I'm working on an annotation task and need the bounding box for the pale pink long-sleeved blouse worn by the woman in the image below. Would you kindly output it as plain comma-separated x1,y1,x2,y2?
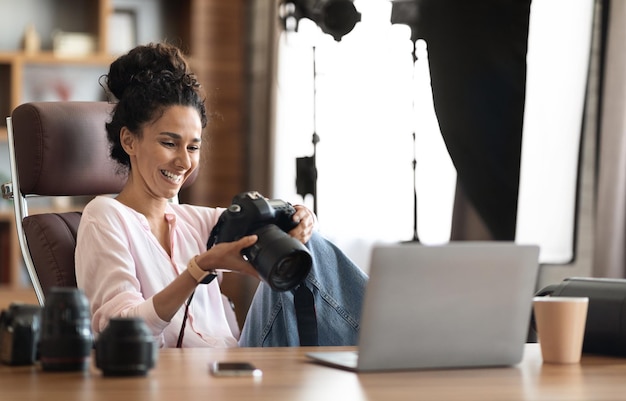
76,196,237,347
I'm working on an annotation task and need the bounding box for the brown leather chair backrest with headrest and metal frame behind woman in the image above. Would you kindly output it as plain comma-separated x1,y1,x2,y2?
7,102,125,305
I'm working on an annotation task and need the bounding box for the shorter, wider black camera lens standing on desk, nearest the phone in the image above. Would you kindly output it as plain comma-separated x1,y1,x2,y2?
96,318,157,376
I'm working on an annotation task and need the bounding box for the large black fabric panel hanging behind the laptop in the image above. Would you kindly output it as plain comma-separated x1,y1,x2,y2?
394,0,531,240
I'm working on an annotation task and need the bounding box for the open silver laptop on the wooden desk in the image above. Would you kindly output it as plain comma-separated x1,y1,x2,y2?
307,242,539,372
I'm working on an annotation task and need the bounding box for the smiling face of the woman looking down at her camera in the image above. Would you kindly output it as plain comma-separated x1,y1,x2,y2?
120,106,202,199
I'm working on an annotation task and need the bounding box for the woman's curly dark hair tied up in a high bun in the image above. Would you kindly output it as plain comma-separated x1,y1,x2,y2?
103,43,208,171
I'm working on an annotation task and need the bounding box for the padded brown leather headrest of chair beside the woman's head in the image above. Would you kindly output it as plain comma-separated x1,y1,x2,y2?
11,102,197,196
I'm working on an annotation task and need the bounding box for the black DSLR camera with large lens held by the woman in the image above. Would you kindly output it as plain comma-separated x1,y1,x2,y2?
207,191,313,291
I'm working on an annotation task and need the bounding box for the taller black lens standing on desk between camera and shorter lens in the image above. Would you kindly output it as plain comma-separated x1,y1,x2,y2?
40,287,93,371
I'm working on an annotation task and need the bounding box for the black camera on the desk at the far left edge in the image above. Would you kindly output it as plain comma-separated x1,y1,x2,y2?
0,303,42,365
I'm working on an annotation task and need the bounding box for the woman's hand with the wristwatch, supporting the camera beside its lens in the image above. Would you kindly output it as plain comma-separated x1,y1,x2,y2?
196,235,260,279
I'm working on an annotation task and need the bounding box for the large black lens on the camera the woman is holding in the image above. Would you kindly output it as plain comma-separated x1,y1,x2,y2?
244,224,313,291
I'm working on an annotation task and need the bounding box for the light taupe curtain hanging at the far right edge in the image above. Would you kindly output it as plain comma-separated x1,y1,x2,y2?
593,0,626,278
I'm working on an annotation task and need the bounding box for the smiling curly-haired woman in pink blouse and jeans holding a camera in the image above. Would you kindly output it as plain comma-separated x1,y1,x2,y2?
76,44,366,347
